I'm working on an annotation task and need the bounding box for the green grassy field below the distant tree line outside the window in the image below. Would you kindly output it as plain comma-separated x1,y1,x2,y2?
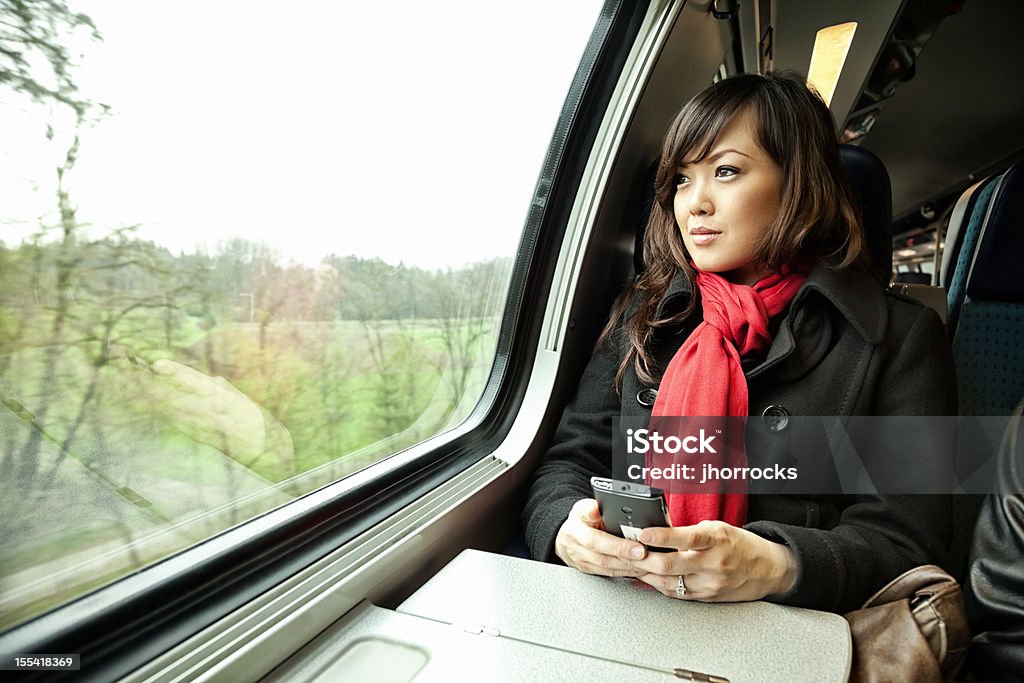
0,310,497,624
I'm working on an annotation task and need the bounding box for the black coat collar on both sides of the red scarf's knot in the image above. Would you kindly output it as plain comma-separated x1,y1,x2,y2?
657,263,887,344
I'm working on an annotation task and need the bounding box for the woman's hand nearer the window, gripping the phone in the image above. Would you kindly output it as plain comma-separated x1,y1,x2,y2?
555,498,647,577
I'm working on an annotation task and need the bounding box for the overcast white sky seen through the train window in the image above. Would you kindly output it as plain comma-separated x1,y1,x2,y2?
0,0,601,267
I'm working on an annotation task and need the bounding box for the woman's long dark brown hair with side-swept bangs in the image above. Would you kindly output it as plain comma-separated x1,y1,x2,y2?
598,73,866,389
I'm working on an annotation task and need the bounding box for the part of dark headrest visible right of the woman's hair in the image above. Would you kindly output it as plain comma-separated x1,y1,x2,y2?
839,144,893,275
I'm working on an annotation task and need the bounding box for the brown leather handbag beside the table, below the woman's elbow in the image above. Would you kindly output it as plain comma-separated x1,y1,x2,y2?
845,564,971,682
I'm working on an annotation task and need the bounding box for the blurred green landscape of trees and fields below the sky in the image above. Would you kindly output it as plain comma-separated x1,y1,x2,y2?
0,229,510,626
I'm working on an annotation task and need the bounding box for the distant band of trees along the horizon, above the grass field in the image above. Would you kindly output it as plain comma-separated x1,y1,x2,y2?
0,236,511,327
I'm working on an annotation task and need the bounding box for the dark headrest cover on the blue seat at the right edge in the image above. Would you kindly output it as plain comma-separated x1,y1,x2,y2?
967,162,1024,303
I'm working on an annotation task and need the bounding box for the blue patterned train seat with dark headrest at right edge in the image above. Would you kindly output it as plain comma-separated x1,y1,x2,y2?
950,162,1024,415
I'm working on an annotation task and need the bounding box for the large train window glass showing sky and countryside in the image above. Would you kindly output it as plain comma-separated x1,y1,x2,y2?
0,0,601,628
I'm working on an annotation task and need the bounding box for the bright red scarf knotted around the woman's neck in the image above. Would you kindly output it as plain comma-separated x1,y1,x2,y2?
651,270,806,526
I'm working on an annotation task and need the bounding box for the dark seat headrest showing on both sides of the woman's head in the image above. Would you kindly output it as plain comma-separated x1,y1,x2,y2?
633,144,893,275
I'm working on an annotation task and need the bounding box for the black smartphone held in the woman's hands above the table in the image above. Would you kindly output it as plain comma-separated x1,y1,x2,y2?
590,477,676,553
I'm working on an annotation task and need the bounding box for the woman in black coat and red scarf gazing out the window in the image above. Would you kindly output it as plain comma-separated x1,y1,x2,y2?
524,75,956,611
